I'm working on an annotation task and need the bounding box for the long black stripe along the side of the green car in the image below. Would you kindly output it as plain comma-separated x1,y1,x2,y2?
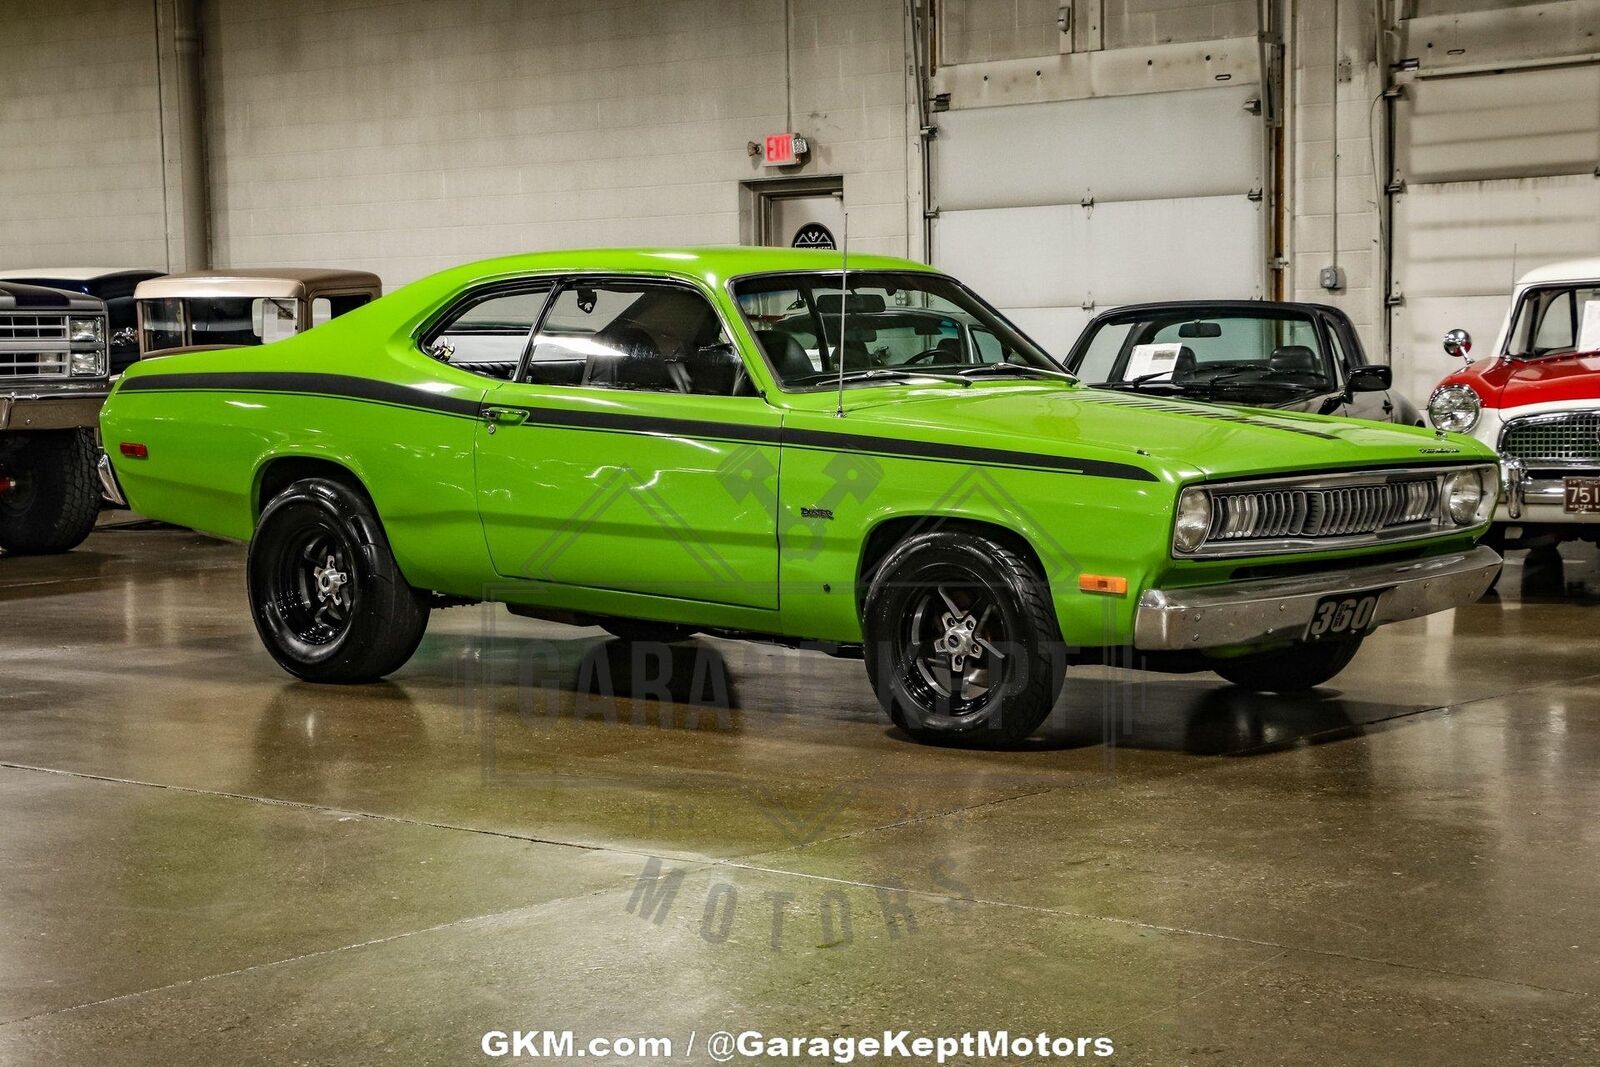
120,371,1158,482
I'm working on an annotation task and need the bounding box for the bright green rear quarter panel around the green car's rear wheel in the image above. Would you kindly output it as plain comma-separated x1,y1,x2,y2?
101,331,488,592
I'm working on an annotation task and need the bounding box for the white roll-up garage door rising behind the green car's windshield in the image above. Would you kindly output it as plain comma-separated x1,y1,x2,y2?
933,85,1266,354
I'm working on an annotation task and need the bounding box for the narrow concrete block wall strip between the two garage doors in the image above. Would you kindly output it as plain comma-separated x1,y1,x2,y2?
1286,0,1386,358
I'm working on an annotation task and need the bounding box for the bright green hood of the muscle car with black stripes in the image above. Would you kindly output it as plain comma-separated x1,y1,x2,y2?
812,384,1494,478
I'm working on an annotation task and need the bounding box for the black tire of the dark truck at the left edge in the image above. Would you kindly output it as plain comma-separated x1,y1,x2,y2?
0,429,101,555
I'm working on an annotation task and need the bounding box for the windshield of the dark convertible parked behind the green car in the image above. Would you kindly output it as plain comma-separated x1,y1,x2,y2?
1067,307,1338,395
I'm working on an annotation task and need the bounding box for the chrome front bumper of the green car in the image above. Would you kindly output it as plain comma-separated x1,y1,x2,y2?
1133,545,1501,651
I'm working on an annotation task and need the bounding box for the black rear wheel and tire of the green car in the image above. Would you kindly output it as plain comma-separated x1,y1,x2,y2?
246,478,429,681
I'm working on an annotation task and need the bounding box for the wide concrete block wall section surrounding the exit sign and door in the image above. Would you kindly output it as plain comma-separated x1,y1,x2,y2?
206,0,912,286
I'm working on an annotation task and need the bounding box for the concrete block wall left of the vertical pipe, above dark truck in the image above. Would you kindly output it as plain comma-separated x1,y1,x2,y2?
0,0,166,267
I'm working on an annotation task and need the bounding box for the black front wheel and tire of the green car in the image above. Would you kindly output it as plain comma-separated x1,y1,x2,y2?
862,531,1066,745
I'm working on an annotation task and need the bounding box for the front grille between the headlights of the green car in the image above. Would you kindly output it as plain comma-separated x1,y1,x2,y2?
1206,475,1438,544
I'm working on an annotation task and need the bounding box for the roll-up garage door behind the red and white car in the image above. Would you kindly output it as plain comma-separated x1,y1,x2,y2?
1389,64,1600,402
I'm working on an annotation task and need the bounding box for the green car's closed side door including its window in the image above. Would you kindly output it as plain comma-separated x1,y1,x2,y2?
477,277,781,609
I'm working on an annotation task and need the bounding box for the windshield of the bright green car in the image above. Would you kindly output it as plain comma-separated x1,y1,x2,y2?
733,270,1066,389
